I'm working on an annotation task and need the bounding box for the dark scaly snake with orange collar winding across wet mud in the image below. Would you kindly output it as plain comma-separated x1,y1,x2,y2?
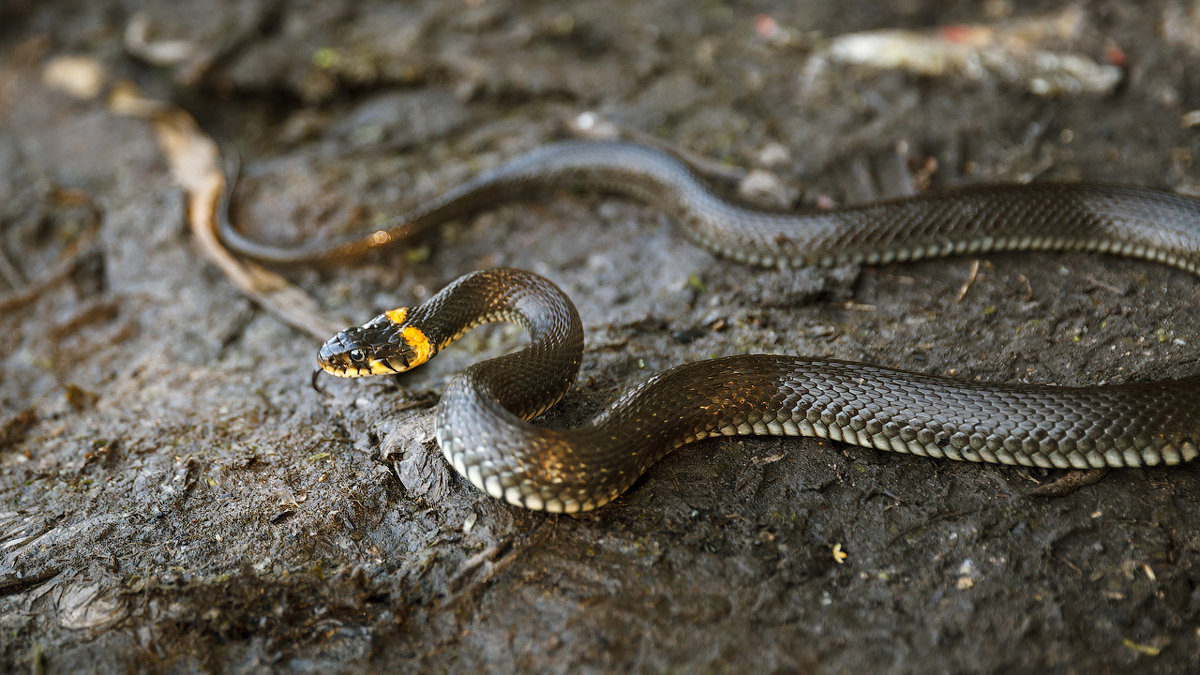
222,141,1200,513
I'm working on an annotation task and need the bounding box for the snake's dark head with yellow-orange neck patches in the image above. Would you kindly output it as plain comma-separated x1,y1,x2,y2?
317,309,436,377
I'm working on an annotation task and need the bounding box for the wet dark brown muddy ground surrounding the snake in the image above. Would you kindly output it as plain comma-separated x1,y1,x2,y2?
0,0,1200,673
